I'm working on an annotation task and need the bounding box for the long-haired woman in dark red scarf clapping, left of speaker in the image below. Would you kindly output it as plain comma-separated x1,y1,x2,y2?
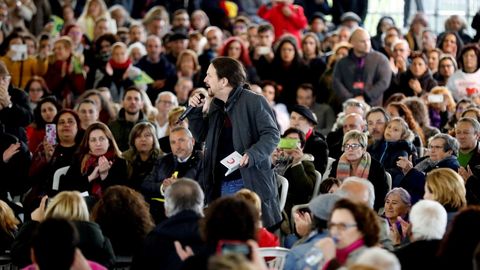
59,122,127,199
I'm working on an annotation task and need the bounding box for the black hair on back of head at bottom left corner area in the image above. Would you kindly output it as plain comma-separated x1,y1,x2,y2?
32,218,79,270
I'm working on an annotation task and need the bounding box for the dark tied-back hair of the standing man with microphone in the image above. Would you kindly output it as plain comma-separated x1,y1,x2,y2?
212,57,247,88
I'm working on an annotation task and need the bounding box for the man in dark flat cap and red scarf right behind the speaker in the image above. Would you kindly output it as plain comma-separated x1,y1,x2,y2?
290,105,328,174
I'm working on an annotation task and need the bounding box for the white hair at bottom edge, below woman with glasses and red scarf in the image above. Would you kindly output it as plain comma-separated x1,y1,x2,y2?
355,247,402,270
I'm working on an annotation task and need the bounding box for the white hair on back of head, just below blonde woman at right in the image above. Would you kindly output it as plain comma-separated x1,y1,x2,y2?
409,200,447,241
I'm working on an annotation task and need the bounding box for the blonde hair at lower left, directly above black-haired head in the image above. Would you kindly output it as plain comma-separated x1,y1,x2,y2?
45,191,90,221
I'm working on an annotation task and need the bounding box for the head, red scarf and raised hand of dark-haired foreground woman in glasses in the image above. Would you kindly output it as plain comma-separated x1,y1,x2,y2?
315,199,380,269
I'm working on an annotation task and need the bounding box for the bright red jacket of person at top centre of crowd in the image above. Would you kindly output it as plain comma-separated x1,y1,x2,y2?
258,3,308,46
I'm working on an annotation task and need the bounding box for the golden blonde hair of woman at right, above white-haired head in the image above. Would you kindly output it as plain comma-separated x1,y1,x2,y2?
425,168,467,209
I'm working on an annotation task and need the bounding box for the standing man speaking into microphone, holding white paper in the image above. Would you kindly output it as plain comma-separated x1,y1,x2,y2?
187,57,281,227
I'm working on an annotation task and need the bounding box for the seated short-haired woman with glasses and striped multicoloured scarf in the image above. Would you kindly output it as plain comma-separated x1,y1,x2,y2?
330,130,388,210
